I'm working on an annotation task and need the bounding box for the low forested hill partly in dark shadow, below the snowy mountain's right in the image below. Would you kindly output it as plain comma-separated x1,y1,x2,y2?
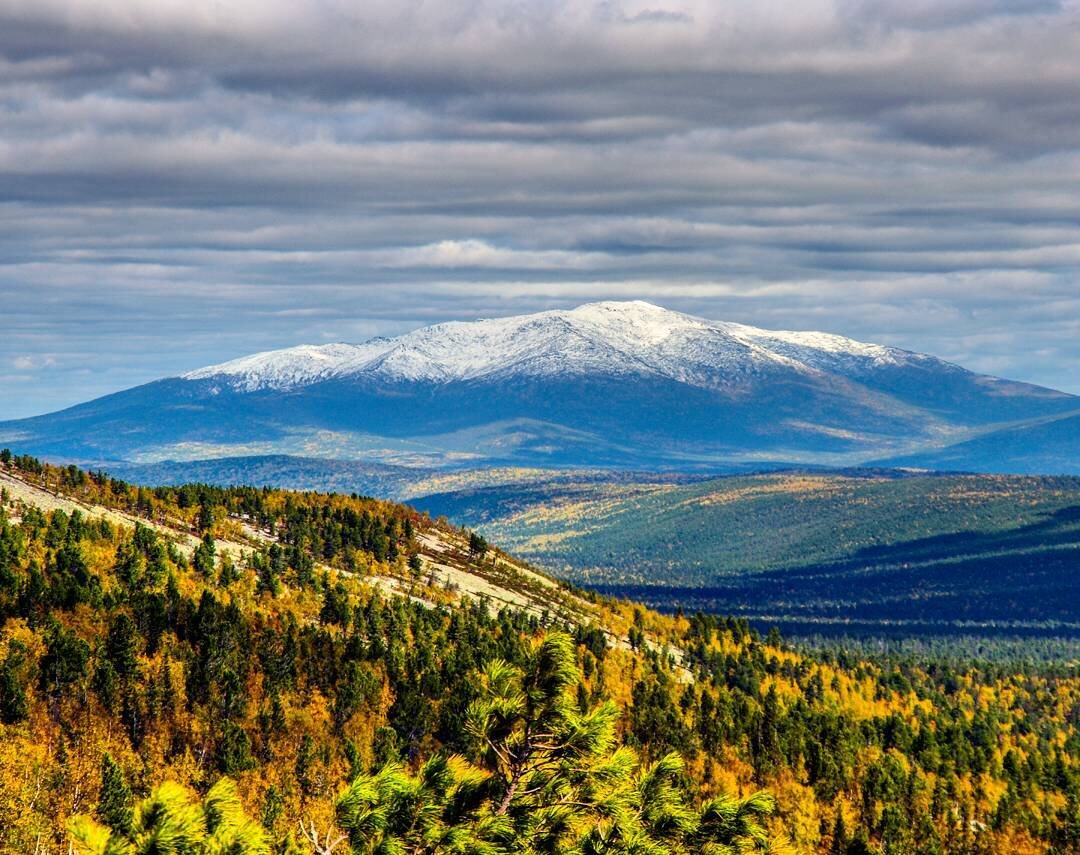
416,470,1080,638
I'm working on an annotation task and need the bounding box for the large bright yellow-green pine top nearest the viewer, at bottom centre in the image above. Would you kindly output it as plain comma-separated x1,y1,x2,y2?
337,634,773,853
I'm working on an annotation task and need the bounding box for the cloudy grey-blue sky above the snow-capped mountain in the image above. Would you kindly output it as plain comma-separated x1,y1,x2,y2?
0,0,1080,419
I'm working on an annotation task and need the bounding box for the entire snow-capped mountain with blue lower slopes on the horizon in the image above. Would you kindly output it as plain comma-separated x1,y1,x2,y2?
0,301,1080,470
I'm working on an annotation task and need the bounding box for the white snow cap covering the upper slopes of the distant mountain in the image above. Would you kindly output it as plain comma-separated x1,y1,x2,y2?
184,300,914,391
